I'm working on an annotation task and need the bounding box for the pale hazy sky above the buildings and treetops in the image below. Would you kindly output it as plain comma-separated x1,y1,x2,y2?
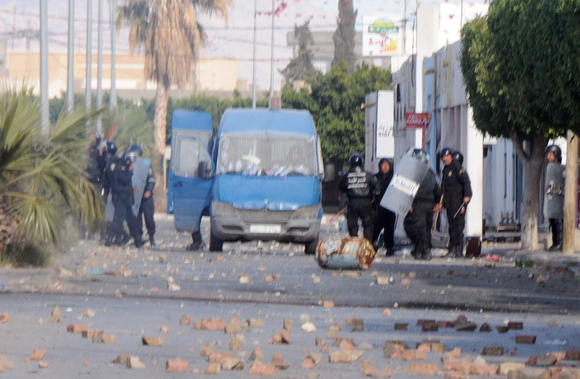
0,0,483,90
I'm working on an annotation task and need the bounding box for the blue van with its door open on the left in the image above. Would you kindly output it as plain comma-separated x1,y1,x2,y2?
168,109,332,254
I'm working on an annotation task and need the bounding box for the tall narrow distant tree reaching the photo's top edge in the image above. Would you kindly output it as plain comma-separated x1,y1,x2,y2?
331,0,358,73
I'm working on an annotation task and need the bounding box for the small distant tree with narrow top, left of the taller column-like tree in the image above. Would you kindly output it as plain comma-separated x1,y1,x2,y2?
280,21,317,82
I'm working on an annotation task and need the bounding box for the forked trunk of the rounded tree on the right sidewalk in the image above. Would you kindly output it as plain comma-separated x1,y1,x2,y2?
511,132,548,250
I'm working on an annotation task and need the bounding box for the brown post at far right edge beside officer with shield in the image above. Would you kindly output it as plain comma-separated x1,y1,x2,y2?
562,130,578,254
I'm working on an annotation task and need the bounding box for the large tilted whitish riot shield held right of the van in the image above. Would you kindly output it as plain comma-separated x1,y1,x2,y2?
380,154,429,217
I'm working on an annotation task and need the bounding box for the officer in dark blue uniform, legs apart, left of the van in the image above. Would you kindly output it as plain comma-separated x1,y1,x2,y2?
105,156,144,247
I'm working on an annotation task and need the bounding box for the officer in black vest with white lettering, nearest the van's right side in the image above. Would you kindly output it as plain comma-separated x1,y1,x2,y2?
339,153,381,242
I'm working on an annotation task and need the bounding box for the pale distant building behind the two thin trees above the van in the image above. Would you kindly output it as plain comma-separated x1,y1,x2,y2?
286,31,391,74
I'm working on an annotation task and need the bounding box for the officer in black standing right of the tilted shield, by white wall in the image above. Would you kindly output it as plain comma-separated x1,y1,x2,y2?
441,160,472,257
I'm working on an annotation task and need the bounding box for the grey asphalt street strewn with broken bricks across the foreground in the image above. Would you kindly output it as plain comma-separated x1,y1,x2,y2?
0,215,580,378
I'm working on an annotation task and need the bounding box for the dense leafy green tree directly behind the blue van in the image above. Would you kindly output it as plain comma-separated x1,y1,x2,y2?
282,62,391,167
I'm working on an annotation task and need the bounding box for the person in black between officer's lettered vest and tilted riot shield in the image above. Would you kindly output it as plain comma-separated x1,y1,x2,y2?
373,158,397,256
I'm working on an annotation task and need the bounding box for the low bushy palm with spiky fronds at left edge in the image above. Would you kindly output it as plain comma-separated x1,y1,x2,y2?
0,85,102,257
